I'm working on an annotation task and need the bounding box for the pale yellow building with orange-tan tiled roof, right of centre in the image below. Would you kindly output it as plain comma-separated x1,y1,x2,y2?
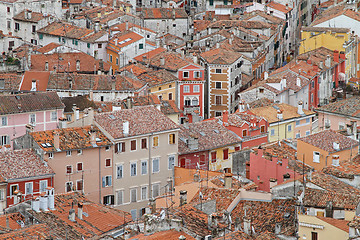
250,103,315,142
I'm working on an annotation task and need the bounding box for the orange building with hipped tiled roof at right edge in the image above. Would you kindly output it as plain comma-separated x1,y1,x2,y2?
297,130,359,171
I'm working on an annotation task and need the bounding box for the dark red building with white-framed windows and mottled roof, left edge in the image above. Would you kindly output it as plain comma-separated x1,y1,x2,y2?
0,149,55,207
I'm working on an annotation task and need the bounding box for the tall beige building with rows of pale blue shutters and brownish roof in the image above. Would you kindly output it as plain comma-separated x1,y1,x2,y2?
95,106,179,219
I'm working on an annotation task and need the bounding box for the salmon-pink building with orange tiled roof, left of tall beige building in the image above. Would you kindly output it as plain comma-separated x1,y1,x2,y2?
15,126,114,205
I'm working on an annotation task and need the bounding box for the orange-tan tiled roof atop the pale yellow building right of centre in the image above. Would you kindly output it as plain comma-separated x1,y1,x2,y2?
250,103,315,123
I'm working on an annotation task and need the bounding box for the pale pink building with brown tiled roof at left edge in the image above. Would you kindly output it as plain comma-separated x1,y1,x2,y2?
0,92,64,148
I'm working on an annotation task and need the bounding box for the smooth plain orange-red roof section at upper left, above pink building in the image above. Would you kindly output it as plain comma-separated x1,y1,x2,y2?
19,71,50,92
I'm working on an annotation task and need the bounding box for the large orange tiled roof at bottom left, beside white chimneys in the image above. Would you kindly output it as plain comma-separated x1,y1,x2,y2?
30,193,131,240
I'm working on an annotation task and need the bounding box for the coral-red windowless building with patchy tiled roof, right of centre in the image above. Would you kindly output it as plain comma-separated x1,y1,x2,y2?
247,142,309,192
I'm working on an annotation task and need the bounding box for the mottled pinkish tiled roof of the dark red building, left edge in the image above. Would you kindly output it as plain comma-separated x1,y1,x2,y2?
0,149,54,180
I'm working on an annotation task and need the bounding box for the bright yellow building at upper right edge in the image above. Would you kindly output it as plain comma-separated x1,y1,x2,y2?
299,27,357,77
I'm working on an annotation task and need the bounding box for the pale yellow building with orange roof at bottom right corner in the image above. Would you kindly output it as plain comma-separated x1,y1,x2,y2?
298,214,349,240
